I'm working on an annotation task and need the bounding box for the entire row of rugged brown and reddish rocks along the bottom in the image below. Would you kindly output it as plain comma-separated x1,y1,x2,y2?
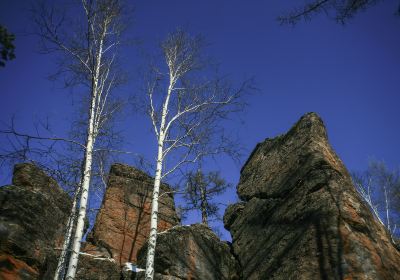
0,113,400,280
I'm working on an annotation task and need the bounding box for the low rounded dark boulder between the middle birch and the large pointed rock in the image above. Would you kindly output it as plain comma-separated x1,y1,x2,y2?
138,224,240,280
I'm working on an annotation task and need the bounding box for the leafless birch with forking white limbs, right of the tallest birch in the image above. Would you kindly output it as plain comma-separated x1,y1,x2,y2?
145,31,245,280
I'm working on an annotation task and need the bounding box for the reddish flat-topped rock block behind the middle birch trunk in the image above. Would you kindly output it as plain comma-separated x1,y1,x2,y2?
88,164,179,265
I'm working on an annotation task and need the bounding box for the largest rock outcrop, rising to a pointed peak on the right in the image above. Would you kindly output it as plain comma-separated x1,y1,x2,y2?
224,113,400,280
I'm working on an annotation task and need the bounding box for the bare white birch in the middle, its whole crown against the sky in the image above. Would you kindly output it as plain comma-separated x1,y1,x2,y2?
145,30,249,280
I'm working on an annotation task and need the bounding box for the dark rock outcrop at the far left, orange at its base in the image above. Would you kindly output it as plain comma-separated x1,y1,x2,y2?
0,163,71,279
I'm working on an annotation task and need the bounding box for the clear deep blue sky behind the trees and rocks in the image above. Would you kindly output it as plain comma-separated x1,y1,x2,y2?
0,0,400,240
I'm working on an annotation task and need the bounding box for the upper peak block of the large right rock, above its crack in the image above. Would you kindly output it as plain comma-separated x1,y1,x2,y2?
237,113,347,200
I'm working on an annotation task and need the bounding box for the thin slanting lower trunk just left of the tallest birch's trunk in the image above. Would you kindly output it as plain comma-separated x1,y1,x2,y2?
54,187,80,280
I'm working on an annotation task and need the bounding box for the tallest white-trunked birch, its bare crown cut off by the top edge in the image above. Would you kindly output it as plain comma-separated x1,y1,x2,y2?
35,0,123,279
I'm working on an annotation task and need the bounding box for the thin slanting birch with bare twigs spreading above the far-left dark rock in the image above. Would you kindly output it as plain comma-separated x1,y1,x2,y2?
0,112,121,279
